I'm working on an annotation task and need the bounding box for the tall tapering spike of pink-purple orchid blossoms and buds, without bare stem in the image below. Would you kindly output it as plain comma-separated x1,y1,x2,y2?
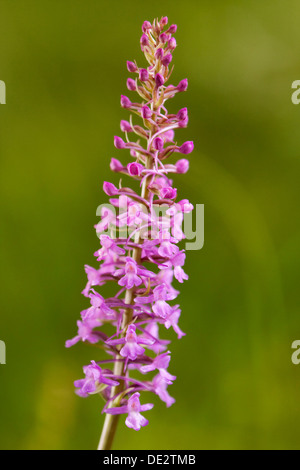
66,17,193,436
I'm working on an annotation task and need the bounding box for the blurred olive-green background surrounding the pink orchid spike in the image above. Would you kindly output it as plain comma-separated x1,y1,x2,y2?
0,0,300,450
